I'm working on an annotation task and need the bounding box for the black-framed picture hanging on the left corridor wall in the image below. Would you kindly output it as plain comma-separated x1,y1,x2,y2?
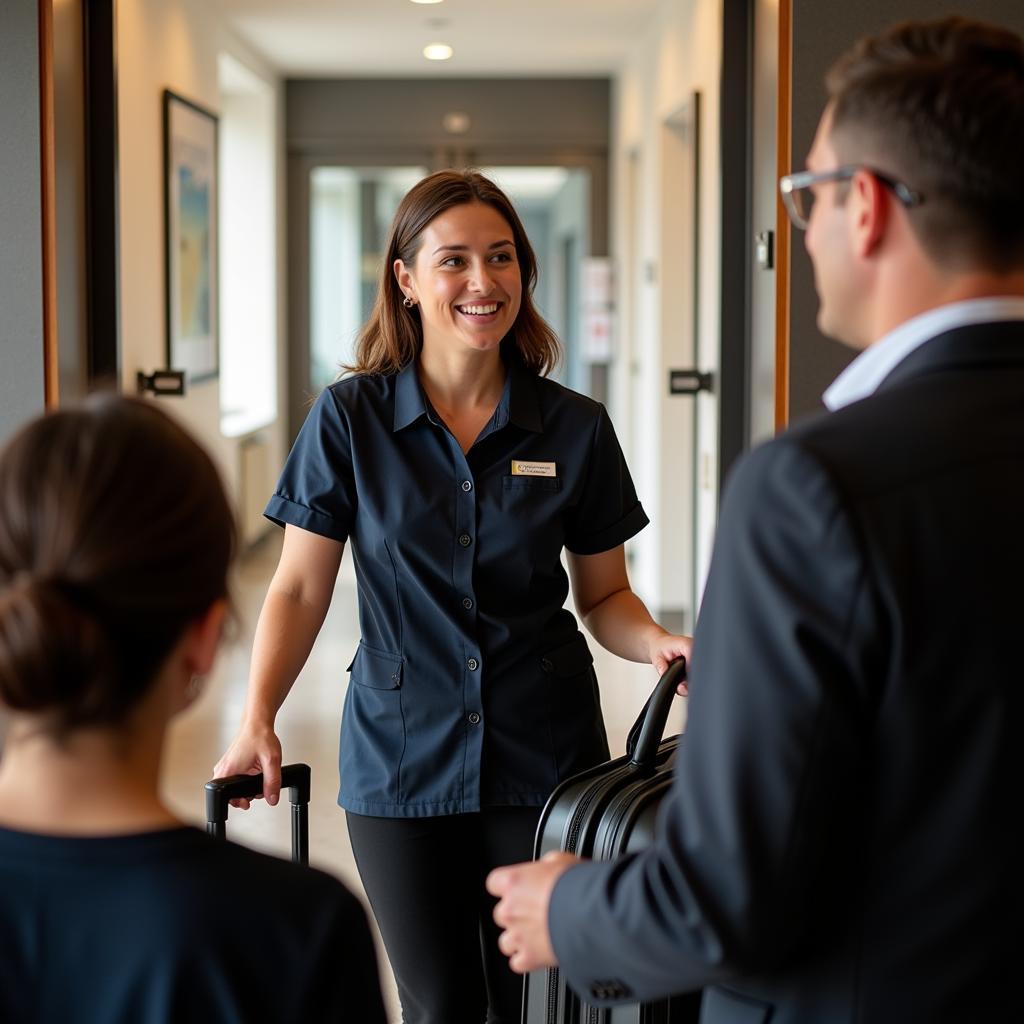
164,89,219,383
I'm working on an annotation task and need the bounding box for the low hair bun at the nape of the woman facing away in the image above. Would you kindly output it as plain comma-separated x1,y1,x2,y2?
0,572,112,718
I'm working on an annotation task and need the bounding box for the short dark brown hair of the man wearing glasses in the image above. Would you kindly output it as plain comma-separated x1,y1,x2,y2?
825,16,1024,272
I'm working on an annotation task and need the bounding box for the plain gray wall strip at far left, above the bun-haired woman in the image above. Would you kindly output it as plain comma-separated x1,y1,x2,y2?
0,0,44,441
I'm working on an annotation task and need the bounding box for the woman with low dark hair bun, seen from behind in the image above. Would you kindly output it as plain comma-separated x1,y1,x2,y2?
0,397,384,1024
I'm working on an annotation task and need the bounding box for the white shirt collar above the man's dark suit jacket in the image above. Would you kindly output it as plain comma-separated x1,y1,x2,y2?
822,296,1024,410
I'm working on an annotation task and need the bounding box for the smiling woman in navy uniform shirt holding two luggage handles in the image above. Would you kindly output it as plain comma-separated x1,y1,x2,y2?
214,171,689,1024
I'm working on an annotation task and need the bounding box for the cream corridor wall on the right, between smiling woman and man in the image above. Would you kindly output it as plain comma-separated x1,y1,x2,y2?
611,0,722,626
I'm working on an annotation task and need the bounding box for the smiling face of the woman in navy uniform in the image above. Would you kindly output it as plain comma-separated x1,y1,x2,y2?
394,203,522,351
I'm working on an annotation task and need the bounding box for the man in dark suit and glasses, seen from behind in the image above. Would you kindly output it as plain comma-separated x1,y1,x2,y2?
488,18,1024,1024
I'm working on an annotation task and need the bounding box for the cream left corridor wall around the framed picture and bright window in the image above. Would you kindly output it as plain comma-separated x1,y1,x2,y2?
117,0,287,540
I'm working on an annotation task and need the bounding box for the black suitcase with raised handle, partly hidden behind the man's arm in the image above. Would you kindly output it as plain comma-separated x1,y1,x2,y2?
522,659,700,1024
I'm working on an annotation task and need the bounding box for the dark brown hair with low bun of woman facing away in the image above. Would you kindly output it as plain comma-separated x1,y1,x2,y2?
0,396,234,734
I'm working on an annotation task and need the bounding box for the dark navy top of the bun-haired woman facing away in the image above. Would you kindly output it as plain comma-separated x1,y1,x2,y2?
0,828,386,1024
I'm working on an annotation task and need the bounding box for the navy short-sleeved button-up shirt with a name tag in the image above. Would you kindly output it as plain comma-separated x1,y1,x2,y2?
266,356,648,817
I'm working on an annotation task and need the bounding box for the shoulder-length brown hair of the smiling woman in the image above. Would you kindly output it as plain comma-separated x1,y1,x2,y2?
343,171,561,374
